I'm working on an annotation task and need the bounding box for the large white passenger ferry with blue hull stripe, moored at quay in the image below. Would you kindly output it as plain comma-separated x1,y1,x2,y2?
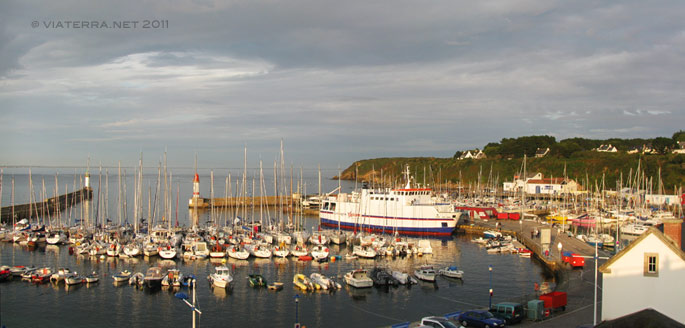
319,167,461,236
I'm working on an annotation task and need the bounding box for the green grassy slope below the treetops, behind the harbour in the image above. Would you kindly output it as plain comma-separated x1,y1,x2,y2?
342,151,685,193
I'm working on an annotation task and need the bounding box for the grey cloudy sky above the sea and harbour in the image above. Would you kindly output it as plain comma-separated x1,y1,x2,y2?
0,0,685,167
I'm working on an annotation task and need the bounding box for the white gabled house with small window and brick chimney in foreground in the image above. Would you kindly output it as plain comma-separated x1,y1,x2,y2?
599,220,685,323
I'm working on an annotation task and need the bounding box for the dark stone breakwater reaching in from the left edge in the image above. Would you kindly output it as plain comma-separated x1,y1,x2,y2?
0,187,93,223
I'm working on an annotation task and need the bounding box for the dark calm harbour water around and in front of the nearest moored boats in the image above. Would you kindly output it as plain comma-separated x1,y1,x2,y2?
0,218,545,328
